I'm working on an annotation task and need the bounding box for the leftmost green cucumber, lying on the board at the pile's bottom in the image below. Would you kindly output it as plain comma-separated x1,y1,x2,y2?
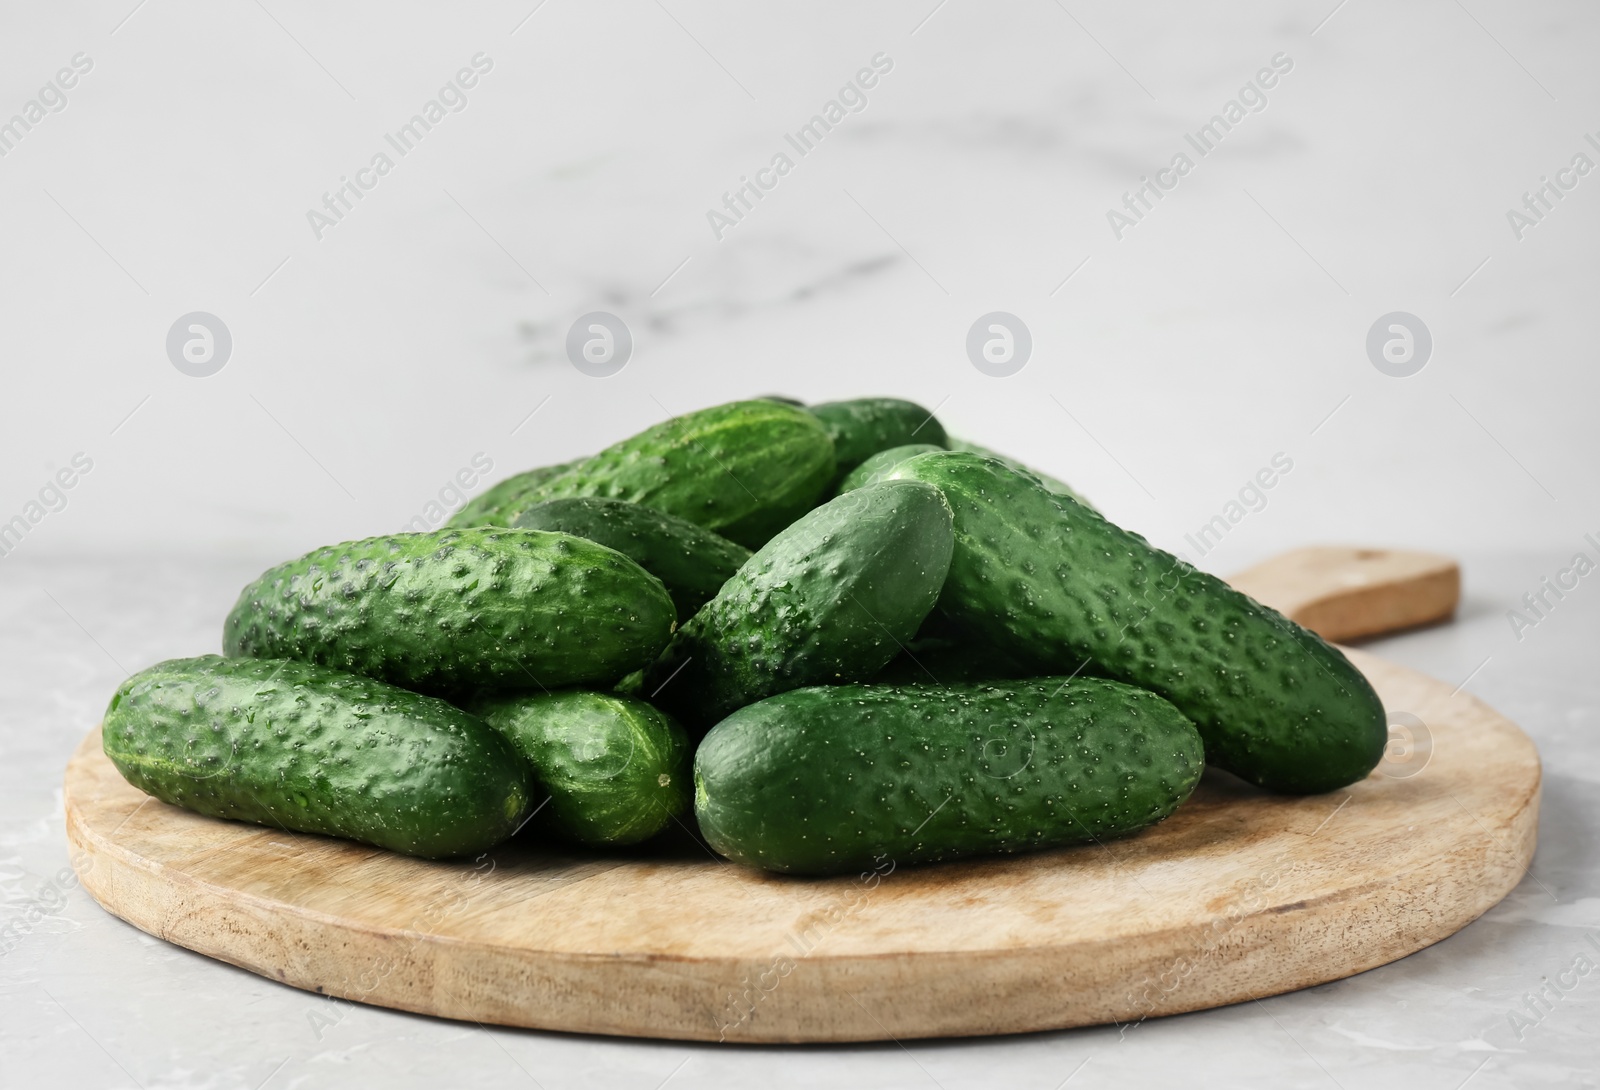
102,655,531,858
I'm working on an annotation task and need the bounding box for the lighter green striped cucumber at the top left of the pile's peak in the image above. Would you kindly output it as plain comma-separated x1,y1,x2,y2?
510,400,834,549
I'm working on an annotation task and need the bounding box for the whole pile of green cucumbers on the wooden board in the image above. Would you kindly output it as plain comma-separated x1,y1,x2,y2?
104,397,1387,874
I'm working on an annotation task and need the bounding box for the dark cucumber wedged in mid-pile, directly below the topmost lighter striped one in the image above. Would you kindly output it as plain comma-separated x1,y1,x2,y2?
515,496,750,618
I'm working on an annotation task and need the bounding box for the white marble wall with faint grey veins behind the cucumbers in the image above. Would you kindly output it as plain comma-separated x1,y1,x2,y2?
0,0,1600,578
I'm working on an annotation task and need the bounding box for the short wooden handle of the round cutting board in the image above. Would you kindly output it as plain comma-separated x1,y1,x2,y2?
1227,546,1461,643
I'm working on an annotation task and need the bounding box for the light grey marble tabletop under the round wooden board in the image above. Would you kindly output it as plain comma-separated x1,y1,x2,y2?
0,554,1600,1090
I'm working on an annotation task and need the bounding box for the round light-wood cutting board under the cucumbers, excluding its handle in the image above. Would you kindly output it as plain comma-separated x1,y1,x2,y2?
66,651,1539,1042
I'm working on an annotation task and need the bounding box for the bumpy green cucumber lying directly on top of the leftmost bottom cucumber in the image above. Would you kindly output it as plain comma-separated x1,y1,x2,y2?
222,527,677,695
